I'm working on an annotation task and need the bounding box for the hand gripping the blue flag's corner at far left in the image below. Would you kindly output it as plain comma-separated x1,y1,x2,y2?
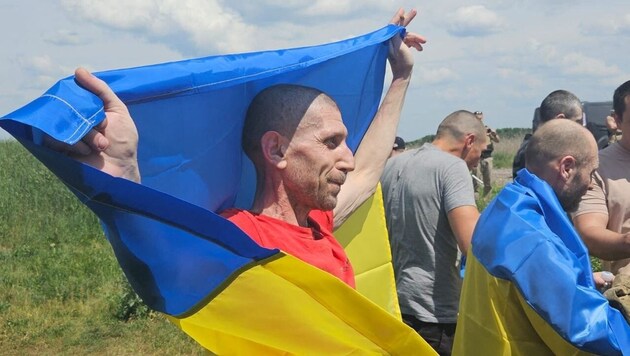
44,68,140,183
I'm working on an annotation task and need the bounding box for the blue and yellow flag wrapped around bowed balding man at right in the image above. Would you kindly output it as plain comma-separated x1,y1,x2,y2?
453,169,630,355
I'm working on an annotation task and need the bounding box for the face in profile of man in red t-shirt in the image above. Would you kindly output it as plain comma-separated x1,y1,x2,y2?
283,100,354,210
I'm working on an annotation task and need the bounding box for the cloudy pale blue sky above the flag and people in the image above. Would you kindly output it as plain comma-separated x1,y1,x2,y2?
0,0,630,140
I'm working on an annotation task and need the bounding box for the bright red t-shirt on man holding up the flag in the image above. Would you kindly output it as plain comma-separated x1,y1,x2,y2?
221,209,355,288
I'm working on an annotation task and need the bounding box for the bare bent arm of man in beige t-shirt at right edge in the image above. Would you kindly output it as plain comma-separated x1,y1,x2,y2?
573,212,630,261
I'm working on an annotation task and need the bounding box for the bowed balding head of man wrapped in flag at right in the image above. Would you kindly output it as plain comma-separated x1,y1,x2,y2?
525,120,599,211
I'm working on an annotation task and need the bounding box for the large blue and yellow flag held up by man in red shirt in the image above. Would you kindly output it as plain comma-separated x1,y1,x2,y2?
0,25,433,354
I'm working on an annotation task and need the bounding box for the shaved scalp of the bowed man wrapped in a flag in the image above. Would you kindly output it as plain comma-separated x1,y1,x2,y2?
525,120,597,173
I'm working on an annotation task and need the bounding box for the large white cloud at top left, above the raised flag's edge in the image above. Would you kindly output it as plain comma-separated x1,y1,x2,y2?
62,0,256,54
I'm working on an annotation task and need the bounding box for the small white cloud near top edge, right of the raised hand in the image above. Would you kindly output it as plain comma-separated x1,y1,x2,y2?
447,5,504,37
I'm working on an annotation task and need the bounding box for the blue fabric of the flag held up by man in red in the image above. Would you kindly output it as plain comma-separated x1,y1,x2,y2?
0,25,404,316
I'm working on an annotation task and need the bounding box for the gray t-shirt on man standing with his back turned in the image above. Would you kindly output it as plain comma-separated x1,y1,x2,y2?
381,143,475,323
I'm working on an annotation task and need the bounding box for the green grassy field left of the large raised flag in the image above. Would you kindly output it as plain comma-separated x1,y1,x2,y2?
0,141,205,355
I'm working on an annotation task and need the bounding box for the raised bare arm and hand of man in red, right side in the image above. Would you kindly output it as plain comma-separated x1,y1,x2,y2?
334,9,426,231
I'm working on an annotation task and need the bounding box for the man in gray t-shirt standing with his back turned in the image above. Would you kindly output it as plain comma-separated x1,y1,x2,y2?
381,111,487,354
